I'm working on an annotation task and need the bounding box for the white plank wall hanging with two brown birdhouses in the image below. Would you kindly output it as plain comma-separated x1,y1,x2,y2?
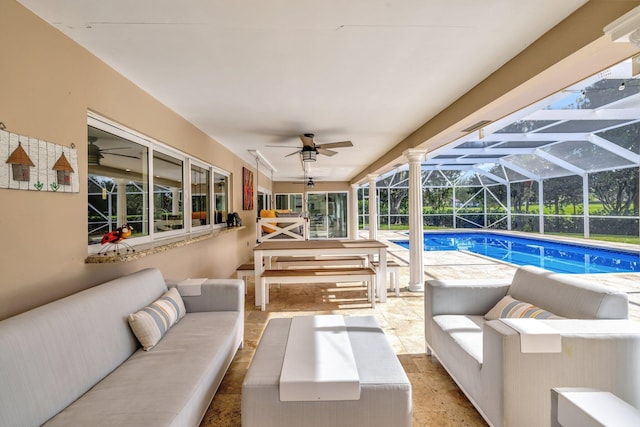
0,126,80,193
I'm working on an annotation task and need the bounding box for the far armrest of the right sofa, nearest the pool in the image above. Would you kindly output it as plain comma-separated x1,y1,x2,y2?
424,280,511,319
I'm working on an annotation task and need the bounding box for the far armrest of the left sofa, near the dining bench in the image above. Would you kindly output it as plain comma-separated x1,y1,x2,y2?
167,279,244,313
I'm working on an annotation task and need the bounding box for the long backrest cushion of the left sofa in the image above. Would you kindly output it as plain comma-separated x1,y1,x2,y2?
0,269,167,426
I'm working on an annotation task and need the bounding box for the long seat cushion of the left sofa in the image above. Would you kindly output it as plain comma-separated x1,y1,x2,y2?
45,311,243,427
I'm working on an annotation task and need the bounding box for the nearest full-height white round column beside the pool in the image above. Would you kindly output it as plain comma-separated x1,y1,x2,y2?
403,150,426,292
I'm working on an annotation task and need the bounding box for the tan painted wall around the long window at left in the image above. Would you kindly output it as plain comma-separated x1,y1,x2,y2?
0,0,255,319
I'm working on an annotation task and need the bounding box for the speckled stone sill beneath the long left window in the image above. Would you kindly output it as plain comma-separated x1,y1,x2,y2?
84,226,247,264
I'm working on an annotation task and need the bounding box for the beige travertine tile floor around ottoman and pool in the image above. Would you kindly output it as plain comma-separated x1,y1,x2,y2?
201,236,640,427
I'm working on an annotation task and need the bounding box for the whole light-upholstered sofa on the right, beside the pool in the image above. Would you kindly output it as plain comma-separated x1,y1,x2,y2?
425,266,640,427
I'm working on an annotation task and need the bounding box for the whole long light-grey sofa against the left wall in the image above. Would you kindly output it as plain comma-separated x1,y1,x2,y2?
0,269,244,427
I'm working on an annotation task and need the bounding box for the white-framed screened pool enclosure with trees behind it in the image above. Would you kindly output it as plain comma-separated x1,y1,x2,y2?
359,57,640,243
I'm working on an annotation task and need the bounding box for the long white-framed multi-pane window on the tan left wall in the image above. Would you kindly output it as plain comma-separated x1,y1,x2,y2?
87,114,230,253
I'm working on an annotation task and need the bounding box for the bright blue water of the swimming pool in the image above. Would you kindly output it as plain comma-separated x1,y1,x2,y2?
394,233,640,274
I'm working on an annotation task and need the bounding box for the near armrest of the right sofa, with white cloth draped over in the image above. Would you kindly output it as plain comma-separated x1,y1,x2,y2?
480,319,640,426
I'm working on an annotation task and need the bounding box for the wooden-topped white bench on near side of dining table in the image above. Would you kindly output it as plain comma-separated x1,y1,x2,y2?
260,267,378,311
